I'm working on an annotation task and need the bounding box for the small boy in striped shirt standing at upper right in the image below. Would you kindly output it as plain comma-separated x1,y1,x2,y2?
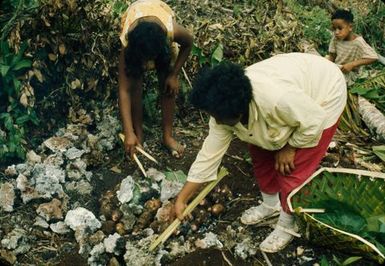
327,9,378,84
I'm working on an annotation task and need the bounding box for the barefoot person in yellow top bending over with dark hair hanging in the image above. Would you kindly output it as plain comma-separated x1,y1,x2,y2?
119,0,193,158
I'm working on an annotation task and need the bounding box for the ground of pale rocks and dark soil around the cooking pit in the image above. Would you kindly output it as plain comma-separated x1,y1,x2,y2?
0,105,375,265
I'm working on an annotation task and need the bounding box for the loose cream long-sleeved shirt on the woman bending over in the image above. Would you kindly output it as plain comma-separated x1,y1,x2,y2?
187,53,346,183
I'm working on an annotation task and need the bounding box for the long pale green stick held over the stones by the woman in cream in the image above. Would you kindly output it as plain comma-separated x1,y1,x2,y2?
149,167,228,251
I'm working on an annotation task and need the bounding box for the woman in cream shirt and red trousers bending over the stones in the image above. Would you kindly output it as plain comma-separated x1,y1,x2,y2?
175,53,346,253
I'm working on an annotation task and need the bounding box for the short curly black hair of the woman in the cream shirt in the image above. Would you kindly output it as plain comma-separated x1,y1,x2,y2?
190,62,252,119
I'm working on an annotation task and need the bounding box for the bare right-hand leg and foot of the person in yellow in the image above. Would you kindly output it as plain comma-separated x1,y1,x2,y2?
158,73,184,158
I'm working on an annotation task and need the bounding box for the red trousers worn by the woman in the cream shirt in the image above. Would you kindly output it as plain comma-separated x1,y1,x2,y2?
249,122,338,213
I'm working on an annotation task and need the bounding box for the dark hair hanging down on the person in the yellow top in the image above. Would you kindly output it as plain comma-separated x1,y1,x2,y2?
124,21,171,78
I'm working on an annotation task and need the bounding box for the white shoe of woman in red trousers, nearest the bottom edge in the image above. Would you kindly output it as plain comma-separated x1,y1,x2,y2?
259,224,301,253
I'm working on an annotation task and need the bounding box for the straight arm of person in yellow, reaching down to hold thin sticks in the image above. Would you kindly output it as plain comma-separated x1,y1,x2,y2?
119,49,140,156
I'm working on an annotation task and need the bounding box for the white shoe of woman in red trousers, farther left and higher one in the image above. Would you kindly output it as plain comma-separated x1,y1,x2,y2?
241,202,281,225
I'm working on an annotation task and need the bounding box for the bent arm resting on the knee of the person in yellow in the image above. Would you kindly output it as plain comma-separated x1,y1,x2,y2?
166,23,193,94
